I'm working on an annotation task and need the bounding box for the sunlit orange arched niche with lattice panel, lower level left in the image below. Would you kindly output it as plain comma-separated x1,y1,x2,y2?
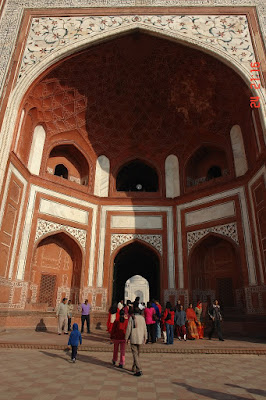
29,232,82,307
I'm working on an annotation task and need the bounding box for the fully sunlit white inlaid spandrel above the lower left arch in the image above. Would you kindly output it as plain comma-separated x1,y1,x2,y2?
34,219,87,250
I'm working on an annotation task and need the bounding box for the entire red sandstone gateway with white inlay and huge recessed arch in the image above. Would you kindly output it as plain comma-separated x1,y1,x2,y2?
0,1,266,332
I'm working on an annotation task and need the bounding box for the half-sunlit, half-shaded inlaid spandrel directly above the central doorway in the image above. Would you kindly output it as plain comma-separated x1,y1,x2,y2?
111,233,163,255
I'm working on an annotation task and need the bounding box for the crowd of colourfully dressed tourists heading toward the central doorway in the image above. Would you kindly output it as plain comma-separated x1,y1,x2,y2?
107,297,224,376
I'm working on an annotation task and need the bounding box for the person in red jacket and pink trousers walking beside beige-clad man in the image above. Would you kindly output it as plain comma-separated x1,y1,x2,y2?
111,309,128,368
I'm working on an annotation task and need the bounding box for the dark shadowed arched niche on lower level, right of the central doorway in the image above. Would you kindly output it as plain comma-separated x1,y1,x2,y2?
189,235,243,308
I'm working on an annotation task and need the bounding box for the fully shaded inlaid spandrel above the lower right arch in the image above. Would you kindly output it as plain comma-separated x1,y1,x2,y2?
187,222,239,254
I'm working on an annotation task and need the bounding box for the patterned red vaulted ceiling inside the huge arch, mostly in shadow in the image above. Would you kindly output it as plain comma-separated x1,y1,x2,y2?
26,32,250,164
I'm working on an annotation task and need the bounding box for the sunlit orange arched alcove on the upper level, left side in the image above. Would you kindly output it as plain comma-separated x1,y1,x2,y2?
47,144,89,186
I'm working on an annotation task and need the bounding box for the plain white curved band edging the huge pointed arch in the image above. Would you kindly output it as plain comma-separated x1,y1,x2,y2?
0,21,266,191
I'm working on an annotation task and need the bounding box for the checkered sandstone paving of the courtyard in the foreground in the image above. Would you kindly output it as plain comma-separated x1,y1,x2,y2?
0,349,266,400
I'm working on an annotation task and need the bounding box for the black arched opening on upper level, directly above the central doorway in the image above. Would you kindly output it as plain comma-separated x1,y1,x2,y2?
116,160,159,192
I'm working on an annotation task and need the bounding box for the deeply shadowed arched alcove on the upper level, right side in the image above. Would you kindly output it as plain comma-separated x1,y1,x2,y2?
185,145,230,187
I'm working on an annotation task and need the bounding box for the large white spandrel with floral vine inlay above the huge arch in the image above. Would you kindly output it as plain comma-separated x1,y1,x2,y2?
19,15,254,77
